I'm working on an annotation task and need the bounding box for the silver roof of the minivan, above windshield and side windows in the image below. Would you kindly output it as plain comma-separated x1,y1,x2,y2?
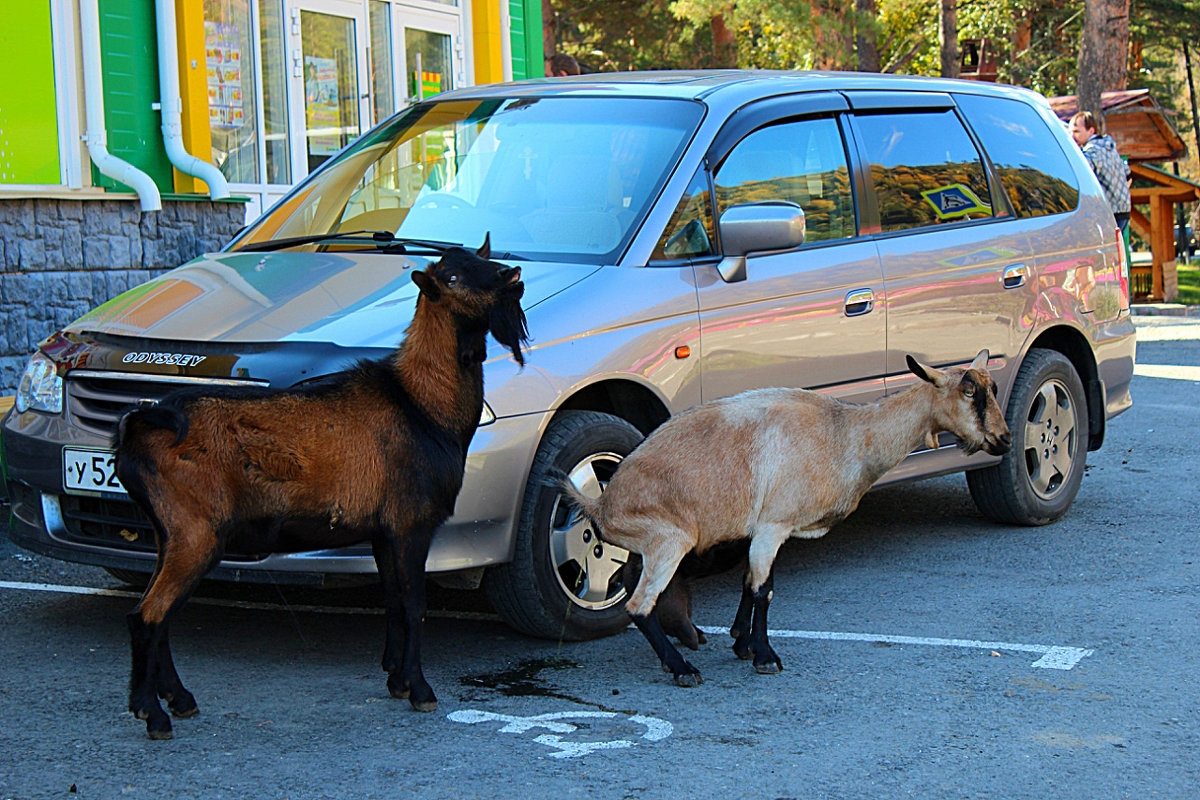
436,70,1045,104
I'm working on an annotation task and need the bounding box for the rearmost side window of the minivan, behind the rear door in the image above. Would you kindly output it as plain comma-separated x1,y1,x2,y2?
954,95,1079,217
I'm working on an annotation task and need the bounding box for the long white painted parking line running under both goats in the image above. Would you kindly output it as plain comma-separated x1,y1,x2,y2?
0,581,1096,669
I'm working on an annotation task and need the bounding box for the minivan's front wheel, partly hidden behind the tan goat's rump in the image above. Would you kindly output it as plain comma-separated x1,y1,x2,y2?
484,411,643,640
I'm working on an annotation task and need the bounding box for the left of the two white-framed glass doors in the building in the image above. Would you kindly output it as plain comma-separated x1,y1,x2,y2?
290,0,368,175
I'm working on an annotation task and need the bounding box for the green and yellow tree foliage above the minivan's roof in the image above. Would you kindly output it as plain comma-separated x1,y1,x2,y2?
545,0,1200,104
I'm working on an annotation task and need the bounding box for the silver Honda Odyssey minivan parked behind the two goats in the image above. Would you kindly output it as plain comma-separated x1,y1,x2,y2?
4,72,1134,638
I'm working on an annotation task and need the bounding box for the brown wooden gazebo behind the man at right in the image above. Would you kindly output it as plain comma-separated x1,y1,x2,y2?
1050,89,1200,300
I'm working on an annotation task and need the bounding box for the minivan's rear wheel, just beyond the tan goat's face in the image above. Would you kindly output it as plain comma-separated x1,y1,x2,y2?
967,348,1088,525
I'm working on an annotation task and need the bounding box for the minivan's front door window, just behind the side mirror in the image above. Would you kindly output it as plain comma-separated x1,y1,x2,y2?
714,118,857,242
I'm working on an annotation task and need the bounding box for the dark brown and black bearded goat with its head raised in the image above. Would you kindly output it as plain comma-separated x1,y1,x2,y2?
116,241,527,739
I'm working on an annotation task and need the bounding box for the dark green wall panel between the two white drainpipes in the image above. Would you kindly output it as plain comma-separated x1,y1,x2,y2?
91,0,175,192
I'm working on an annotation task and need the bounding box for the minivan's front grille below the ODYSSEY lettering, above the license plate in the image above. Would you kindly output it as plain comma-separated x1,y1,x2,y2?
66,369,264,439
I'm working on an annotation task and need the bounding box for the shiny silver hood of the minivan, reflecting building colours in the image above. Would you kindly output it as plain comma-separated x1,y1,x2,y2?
64,252,599,348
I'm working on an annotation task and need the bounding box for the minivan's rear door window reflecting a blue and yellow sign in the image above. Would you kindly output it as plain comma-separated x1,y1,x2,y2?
857,110,992,233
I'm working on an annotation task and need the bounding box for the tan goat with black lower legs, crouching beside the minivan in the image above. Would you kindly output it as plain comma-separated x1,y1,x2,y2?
563,350,1012,686
